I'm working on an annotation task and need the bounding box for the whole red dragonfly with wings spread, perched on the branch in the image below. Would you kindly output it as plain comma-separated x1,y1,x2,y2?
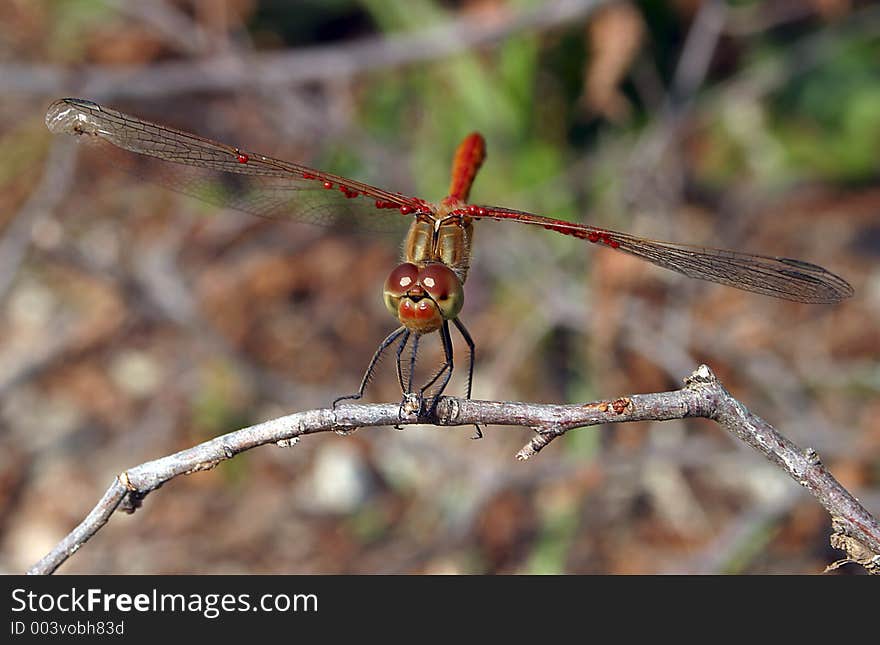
46,98,853,428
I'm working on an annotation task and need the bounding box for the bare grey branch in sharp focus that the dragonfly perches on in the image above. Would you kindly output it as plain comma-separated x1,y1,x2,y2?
28,365,880,574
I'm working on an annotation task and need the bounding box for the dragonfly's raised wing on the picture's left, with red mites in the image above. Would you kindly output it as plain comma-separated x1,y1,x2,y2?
46,98,430,229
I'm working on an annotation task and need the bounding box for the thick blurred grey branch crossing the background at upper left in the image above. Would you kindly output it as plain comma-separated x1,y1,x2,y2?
0,0,609,100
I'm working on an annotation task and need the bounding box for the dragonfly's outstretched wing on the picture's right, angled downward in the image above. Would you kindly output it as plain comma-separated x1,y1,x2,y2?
468,206,853,304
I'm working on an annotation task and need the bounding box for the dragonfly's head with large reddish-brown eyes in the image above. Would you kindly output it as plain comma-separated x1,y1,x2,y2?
383,262,464,334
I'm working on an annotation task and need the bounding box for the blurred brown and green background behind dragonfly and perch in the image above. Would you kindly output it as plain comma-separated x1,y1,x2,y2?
0,0,880,573
